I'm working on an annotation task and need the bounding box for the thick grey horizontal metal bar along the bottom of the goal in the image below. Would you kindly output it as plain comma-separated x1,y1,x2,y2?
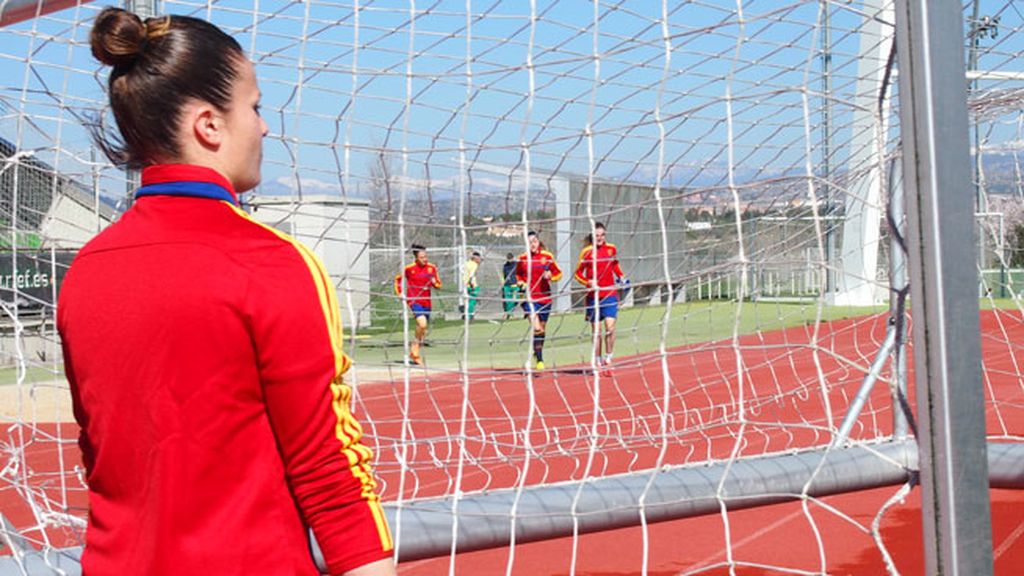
8,441,1024,565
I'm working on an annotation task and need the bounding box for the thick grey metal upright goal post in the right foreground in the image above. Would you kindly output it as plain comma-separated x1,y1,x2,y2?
896,0,992,576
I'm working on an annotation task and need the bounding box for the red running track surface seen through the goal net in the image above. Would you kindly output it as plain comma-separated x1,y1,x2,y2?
0,312,1024,575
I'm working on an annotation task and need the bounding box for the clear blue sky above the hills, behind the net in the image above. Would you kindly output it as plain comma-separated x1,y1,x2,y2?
0,0,1022,206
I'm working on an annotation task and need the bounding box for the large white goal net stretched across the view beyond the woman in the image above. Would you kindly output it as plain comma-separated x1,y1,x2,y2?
0,0,1024,574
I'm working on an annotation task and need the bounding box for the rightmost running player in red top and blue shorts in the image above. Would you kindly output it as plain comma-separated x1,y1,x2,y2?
575,222,626,366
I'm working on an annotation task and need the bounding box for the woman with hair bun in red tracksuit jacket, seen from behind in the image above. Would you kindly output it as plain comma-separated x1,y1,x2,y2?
57,8,394,575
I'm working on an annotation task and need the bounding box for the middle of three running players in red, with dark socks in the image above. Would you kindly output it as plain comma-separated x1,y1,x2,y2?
515,231,562,370
